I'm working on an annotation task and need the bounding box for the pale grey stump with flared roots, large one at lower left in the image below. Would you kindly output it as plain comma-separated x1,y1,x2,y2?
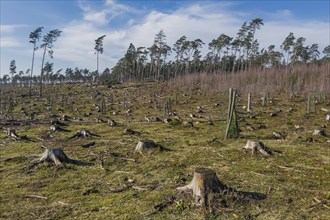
36,148,73,165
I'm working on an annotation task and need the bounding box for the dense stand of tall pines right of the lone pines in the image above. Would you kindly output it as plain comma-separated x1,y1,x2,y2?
107,18,330,81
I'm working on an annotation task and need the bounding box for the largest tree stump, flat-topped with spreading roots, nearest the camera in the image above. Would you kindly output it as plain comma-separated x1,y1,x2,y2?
177,167,230,206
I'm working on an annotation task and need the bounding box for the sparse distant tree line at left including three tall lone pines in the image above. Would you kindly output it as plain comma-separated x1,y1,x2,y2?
0,27,106,96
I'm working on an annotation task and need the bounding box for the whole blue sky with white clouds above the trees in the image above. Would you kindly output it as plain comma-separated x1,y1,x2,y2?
0,0,330,77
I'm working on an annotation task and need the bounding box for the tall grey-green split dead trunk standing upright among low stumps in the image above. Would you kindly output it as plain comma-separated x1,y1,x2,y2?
225,88,239,138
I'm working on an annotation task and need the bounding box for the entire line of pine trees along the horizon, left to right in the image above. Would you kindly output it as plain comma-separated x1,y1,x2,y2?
0,18,330,89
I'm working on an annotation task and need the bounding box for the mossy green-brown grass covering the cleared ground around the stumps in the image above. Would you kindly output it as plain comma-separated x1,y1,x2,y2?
0,83,330,219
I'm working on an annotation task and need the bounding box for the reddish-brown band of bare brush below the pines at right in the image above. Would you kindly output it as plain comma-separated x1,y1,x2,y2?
172,62,330,97
